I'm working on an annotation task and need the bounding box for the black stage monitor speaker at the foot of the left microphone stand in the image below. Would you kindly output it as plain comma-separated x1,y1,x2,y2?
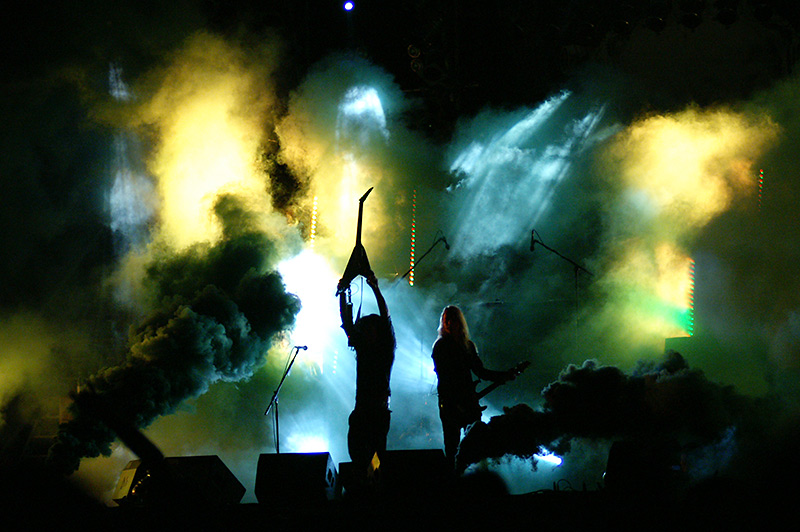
255,452,338,505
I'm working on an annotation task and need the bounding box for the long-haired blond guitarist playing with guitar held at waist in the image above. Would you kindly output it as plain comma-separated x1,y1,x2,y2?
432,305,527,469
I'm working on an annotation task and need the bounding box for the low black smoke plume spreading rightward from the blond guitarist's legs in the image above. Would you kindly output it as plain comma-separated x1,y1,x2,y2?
459,352,763,476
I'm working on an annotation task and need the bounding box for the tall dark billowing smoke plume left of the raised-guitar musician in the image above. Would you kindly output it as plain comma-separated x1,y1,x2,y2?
49,197,300,473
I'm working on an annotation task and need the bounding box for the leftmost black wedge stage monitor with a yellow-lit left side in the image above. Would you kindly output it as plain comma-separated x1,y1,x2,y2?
112,455,246,506
